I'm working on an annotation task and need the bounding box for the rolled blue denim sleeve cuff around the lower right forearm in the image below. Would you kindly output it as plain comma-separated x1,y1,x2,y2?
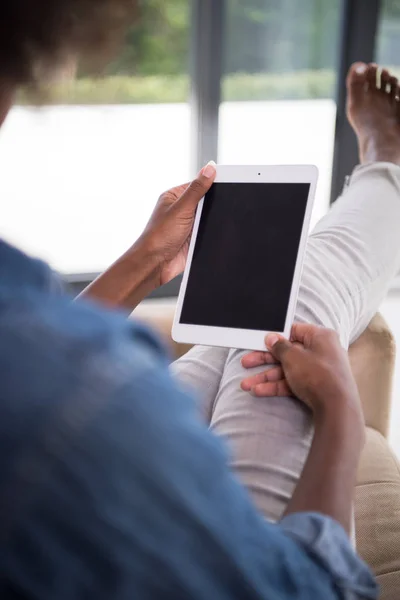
280,513,378,600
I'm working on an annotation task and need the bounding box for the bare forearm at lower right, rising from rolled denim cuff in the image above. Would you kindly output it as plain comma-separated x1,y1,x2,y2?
285,408,364,534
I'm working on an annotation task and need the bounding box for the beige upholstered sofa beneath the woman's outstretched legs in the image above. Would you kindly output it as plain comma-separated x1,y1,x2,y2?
136,303,400,600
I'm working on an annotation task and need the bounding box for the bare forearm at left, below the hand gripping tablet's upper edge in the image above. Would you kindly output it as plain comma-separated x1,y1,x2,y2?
79,243,158,312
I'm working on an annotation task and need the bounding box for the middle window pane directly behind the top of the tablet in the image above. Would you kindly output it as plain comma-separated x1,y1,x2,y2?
219,0,341,227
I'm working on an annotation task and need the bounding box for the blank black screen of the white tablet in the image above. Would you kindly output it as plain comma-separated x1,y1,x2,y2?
180,183,310,331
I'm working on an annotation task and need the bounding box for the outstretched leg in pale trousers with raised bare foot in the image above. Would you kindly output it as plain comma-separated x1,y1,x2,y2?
211,62,400,520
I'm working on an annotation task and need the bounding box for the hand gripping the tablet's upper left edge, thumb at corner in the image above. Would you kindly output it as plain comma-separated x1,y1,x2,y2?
139,162,216,285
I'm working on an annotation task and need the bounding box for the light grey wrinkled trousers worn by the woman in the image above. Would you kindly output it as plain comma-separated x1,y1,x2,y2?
172,163,400,521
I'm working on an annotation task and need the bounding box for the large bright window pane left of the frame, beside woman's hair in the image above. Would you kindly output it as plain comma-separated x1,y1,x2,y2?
0,0,190,273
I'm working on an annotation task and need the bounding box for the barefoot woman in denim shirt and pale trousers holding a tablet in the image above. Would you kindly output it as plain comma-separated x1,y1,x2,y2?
0,0,400,599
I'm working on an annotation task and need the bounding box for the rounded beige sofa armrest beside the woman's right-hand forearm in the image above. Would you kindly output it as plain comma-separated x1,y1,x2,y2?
349,315,396,437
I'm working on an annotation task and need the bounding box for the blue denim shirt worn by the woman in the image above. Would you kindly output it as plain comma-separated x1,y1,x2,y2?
0,242,377,600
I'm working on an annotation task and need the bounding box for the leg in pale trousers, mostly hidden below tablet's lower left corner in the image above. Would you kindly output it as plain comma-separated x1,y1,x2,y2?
171,346,229,424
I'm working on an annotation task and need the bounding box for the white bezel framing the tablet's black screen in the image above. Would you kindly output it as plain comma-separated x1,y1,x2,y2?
172,165,318,350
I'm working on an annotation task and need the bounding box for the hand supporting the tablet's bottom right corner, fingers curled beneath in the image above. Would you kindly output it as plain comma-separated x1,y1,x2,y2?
242,324,362,415
